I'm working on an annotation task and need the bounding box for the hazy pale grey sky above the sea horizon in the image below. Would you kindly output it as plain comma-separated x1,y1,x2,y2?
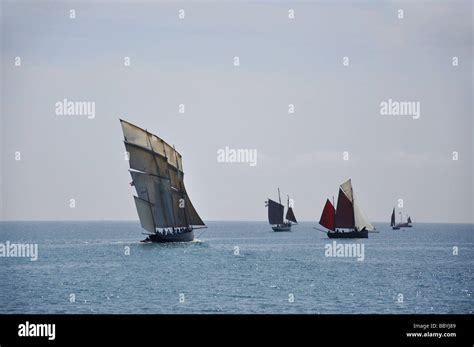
0,1,473,222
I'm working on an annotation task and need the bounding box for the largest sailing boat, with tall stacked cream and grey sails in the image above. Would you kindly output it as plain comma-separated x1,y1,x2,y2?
120,120,206,242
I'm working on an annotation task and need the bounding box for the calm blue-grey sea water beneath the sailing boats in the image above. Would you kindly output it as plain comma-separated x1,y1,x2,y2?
0,222,474,313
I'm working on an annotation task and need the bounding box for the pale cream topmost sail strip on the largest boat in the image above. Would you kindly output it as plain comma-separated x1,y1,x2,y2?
120,119,183,171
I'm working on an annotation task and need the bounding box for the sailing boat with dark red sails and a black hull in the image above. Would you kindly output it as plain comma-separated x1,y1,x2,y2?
319,179,374,239
